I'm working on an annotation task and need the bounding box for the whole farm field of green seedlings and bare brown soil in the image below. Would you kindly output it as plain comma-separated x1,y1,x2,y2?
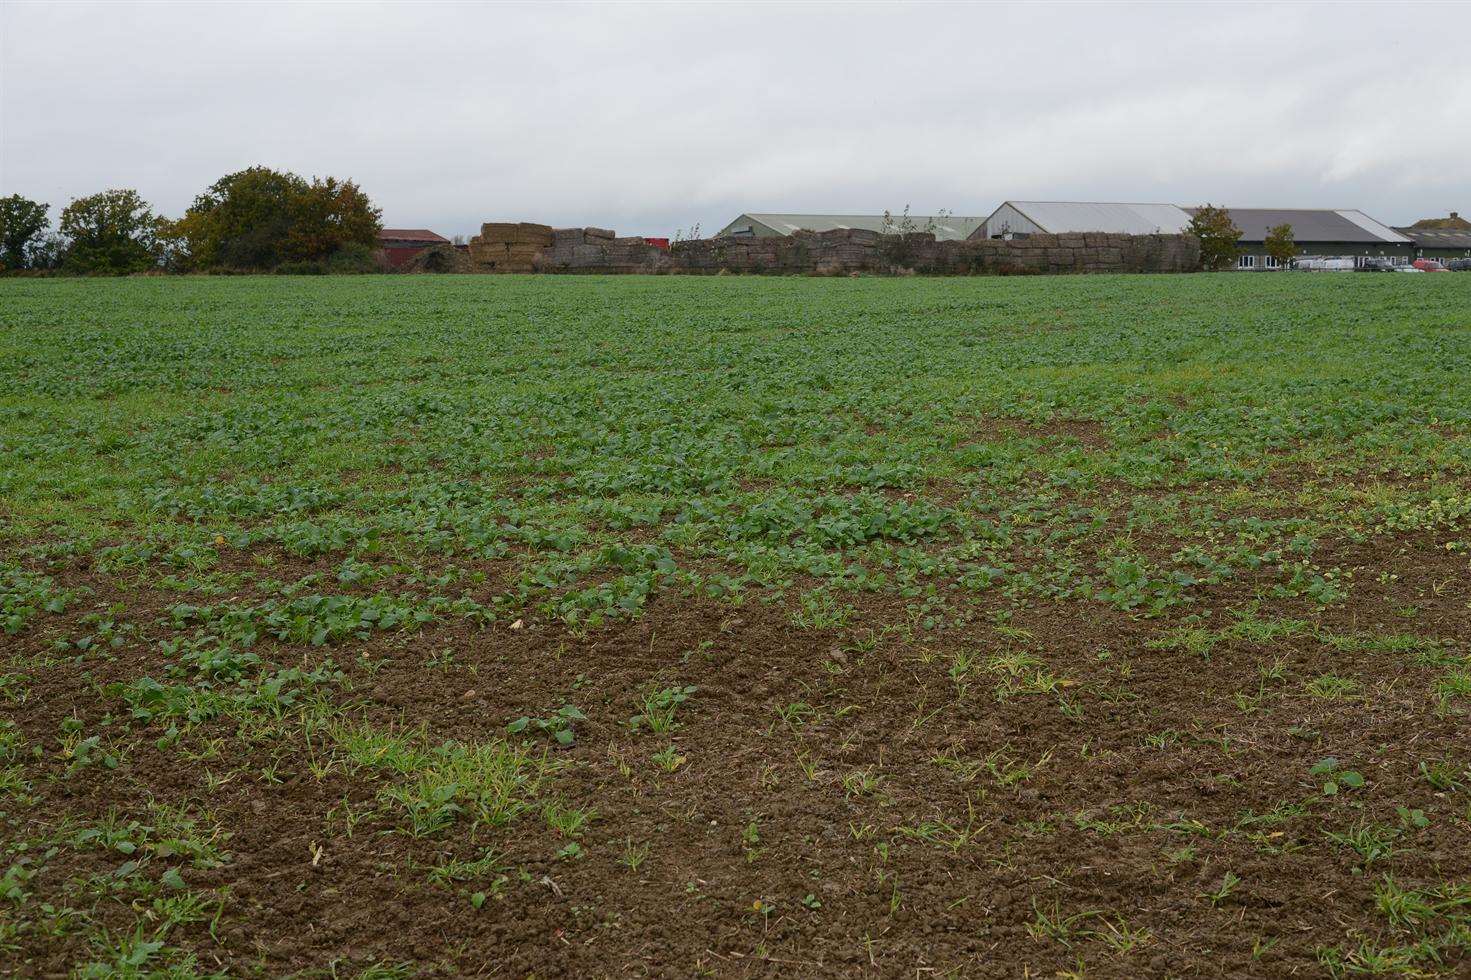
0,274,1471,977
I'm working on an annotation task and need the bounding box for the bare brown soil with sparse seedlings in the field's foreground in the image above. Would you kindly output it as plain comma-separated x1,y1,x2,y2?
11,537,1471,977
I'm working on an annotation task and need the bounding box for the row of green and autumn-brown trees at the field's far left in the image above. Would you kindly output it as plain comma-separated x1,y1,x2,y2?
0,166,382,275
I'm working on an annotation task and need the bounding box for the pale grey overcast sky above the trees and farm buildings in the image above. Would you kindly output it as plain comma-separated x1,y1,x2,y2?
0,0,1471,235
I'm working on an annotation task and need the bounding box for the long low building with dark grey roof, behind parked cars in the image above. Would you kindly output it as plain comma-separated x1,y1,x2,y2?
1186,207,1415,269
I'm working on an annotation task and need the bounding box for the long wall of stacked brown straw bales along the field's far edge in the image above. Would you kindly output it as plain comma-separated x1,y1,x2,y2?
456,222,1200,275
